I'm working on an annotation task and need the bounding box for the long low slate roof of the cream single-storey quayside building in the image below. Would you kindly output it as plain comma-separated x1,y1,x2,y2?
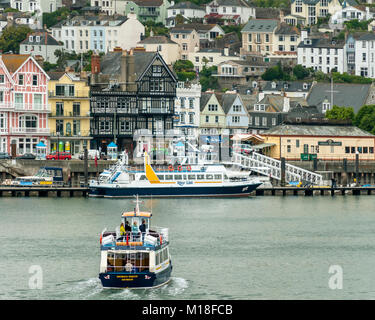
264,124,375,137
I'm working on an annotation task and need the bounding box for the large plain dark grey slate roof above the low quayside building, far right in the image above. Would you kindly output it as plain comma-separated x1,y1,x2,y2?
307,82,371,113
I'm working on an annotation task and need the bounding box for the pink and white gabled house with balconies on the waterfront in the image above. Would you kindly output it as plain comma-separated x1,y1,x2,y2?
0,54,50,156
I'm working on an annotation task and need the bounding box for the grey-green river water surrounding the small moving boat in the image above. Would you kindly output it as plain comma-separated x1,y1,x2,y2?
0,196,375,300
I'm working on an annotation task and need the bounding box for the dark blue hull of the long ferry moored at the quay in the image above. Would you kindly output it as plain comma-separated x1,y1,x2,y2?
89,183,261,197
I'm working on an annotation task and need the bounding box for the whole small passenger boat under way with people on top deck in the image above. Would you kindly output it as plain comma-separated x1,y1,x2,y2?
99,197,172,288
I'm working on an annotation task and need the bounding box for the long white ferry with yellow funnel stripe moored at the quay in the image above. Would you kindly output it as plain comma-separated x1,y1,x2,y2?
89,153,262,197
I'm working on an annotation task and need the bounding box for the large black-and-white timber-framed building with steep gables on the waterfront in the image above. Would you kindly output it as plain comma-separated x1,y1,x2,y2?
90,50,177,154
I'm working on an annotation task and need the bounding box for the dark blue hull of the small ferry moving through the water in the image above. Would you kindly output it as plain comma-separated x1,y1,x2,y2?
99,265,172,289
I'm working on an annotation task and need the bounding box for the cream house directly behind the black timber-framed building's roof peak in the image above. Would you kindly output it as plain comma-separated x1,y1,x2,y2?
137,36,180,65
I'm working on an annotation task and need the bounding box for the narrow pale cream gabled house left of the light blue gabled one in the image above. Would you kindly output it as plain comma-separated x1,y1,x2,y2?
199,92,226,135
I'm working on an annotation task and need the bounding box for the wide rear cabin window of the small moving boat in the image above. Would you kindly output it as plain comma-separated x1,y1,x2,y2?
107,252,150,272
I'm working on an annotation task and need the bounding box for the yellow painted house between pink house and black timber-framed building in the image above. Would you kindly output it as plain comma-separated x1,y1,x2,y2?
48,72,92,155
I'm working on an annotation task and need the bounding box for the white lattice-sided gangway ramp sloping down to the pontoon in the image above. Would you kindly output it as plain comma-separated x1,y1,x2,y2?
232,152,323,186
